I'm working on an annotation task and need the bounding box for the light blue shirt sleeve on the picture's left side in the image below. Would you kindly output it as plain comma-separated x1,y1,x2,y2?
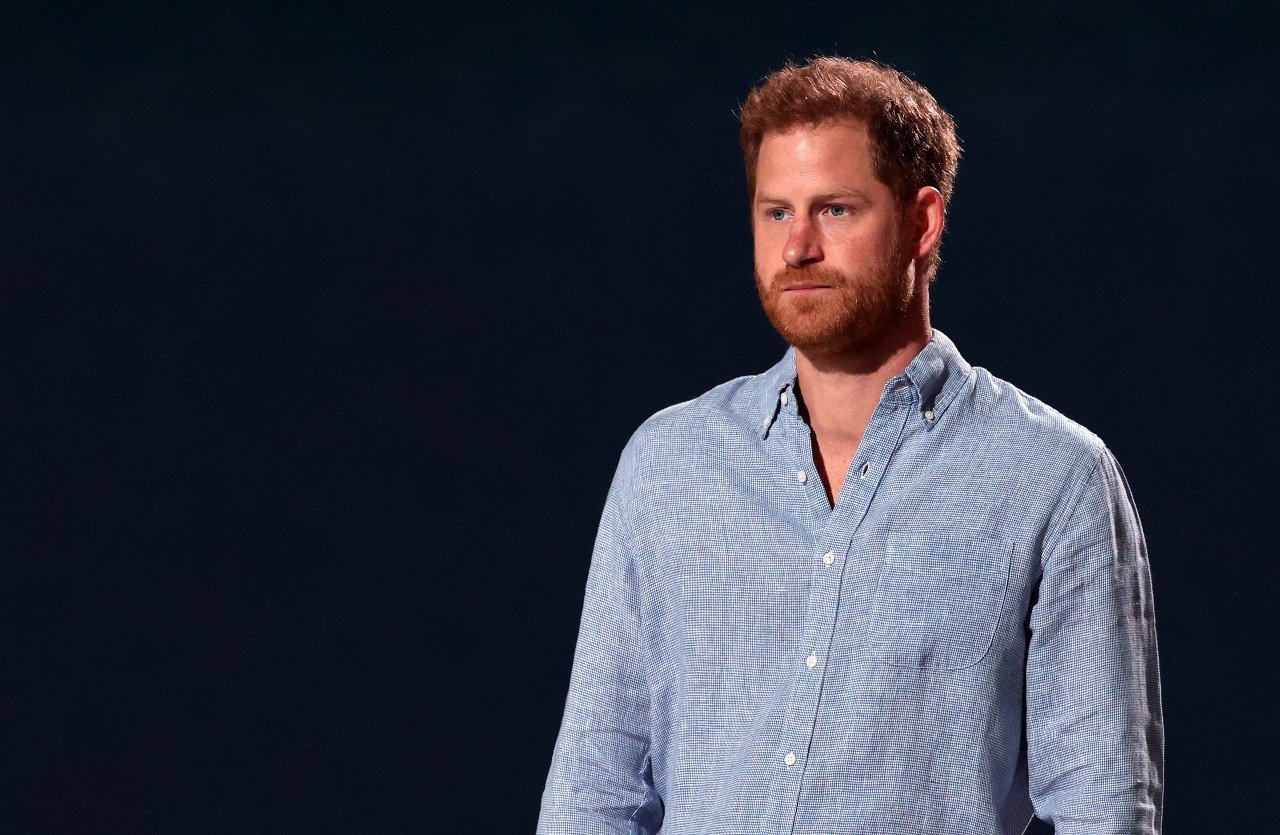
538,437,662,835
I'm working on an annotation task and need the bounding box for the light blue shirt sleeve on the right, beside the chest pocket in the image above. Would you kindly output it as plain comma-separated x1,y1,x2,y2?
1027,447,1165,835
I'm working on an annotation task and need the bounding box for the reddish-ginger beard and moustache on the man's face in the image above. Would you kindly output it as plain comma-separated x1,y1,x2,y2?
755,231,915,359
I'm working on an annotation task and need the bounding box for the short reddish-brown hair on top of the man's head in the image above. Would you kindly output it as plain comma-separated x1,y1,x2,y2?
739,55,960,280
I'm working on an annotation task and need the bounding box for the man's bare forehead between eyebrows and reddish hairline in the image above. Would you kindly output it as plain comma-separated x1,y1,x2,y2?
756,119,876,182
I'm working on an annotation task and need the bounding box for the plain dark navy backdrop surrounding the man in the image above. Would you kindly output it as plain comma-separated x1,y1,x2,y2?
0,1,1280,832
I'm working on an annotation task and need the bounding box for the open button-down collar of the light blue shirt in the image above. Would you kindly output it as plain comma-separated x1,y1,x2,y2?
755,328,973,438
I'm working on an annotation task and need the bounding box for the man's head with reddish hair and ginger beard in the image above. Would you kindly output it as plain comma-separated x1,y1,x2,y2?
741,58,960,353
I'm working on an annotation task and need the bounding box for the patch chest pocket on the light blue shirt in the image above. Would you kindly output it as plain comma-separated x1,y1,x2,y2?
868,529,1012,670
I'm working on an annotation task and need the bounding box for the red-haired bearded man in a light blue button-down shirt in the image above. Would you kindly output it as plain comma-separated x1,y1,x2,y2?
539,58,1164,835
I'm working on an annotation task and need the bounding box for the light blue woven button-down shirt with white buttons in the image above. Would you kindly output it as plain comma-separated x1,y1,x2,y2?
538,329,1164,835
